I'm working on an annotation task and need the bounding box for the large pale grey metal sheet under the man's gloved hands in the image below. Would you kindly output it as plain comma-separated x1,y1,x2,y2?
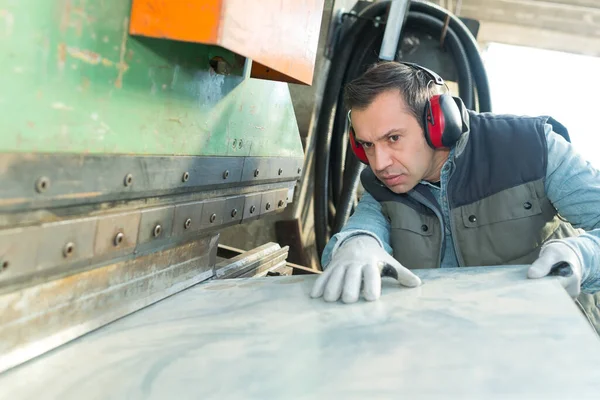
0,266,600,400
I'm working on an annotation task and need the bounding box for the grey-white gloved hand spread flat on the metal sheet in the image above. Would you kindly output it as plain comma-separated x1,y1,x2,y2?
311,235,421,303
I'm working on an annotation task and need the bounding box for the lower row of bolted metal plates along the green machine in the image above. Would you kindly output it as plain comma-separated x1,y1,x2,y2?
0,186,289,293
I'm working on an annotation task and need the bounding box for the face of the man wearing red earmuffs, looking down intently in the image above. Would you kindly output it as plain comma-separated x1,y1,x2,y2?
351,91,435,193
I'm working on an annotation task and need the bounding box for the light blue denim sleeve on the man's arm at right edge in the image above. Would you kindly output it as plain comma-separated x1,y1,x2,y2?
545,124,600,293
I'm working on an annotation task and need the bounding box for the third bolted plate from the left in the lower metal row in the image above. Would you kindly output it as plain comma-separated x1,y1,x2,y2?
94,211,141,256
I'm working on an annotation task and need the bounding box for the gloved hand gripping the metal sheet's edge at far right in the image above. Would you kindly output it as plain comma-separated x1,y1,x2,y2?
527,241,582,298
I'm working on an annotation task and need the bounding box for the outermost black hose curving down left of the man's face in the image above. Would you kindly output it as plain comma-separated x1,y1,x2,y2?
314,2,389,257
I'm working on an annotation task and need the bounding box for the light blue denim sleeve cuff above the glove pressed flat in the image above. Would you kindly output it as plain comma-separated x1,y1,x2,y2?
321,192,392,270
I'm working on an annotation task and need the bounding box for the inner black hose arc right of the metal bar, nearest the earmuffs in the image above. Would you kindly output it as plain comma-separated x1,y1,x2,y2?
406,11,474,110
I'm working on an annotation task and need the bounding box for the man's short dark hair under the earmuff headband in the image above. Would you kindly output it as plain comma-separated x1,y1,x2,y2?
344,61,438,127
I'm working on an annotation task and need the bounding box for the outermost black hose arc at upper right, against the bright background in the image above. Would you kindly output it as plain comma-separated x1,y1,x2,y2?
410,0,492,112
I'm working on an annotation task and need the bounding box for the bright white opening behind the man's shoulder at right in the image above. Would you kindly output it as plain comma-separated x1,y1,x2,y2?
482,43,600,169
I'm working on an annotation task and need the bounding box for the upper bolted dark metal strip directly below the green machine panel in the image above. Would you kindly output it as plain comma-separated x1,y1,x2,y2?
0,154,303,211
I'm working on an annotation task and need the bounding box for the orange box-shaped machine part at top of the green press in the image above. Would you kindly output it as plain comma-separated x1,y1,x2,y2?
129,0,324,85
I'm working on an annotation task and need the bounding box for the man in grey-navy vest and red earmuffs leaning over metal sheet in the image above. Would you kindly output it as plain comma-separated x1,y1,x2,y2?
311,62,600,332
